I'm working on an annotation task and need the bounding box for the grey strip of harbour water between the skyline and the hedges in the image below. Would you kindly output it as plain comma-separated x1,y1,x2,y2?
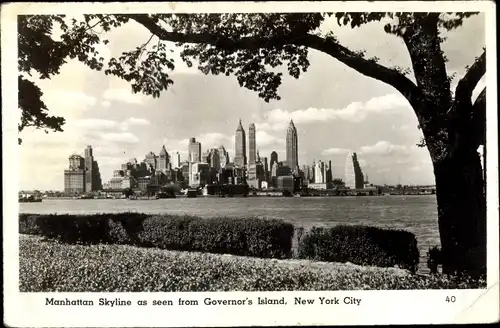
19,195,440,271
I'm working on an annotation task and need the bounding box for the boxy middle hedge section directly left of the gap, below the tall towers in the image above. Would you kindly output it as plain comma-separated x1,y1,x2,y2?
139,216,294,258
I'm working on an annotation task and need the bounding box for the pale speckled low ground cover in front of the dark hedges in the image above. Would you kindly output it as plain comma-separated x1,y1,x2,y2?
19,236,485,292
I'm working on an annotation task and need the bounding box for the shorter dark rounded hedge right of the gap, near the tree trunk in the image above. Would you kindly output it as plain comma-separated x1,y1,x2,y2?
298,225,420,272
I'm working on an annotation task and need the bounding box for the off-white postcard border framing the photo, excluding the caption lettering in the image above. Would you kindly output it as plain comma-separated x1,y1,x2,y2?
1,1,499,327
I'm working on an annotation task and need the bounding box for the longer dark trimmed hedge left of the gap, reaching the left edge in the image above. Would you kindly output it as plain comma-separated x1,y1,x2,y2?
19,213,294,258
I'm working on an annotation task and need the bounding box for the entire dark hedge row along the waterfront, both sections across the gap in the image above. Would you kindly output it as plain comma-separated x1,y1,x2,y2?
19,213,419,272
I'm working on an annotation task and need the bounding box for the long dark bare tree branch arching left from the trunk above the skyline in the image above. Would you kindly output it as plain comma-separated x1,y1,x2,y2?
126,15,421,110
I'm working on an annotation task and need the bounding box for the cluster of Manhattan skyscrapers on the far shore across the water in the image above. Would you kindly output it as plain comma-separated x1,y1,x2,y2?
64,120,366,194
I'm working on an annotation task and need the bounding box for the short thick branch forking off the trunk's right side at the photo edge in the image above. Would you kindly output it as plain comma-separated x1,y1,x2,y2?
455,50,486,107
